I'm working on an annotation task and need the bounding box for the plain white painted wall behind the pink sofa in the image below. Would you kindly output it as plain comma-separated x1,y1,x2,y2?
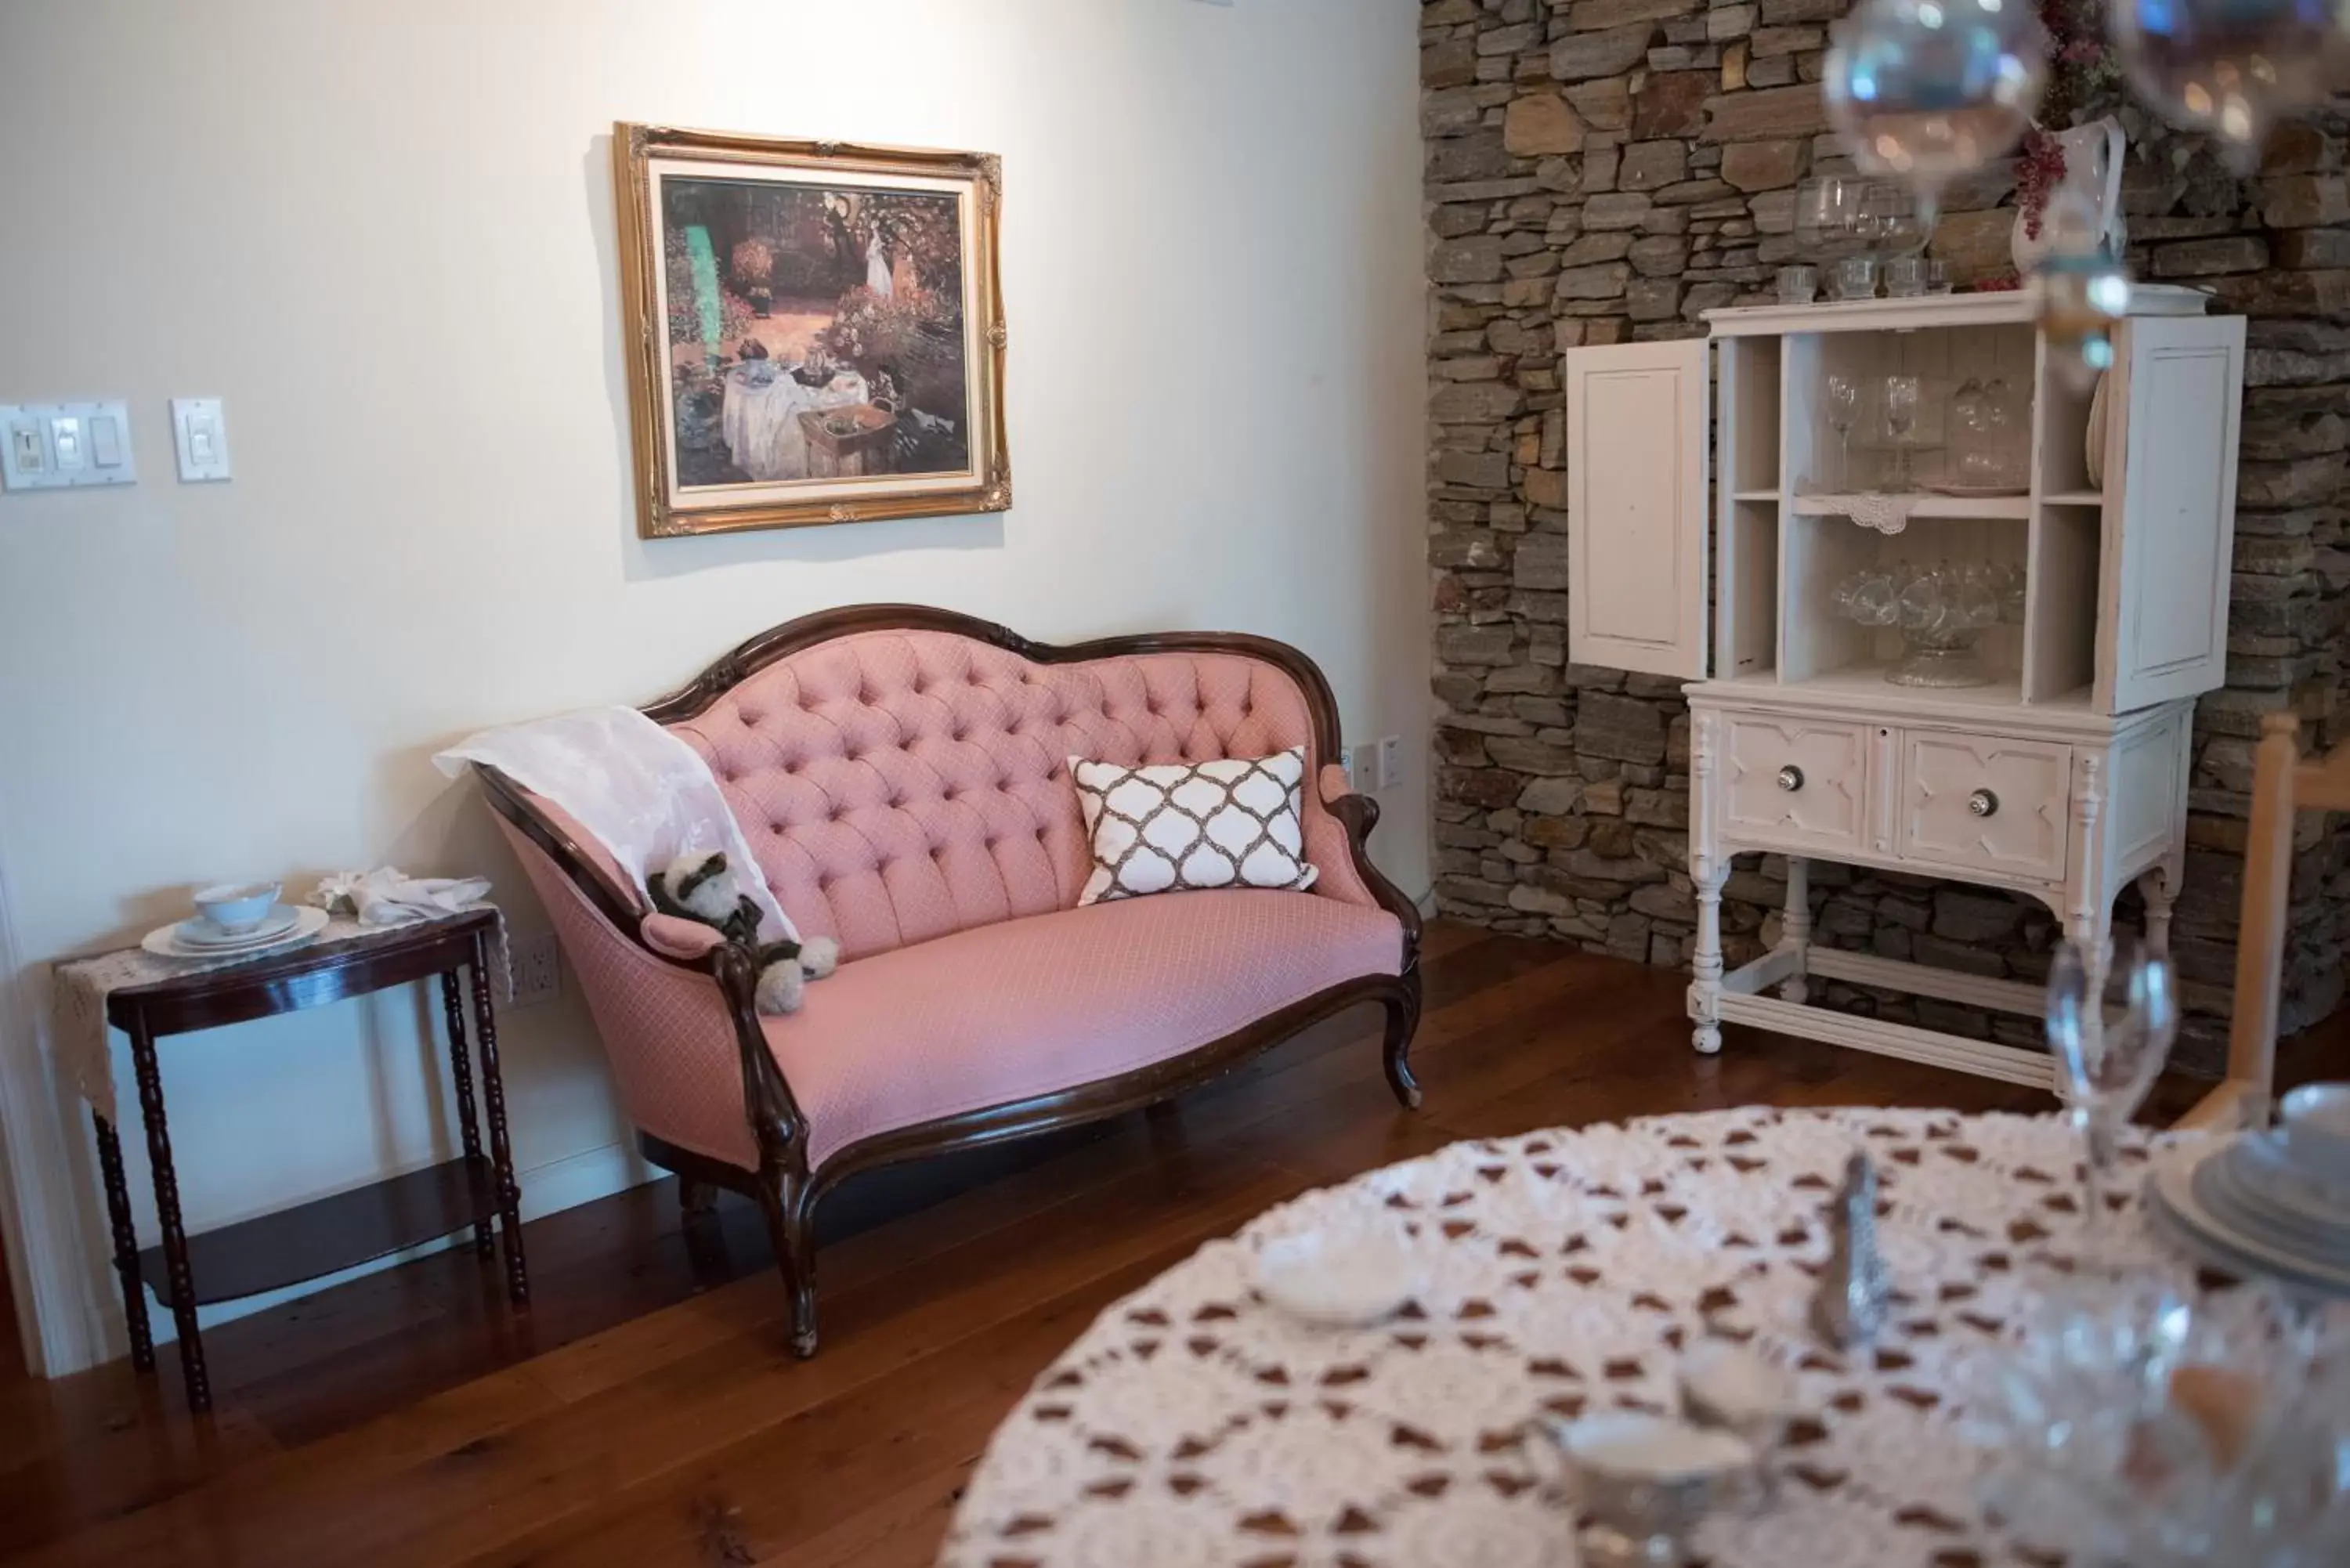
0,0,1429,1366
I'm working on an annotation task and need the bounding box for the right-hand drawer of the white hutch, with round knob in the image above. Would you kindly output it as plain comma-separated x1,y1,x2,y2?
1894,731,2073,882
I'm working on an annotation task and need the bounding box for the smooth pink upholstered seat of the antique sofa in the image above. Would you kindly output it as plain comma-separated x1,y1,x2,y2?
766,889,1403,1166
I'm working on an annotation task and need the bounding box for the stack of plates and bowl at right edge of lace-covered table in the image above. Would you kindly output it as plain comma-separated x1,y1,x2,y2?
2146,1084,2350,1295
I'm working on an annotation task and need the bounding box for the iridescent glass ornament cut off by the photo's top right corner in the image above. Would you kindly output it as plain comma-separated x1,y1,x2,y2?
2108,0,2343,174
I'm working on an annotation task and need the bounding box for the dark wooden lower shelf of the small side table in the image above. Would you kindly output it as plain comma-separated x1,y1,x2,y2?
139,1154,501,1307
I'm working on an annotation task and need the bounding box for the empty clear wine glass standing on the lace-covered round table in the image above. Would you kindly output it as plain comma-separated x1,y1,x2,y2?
2047,943,2178,1248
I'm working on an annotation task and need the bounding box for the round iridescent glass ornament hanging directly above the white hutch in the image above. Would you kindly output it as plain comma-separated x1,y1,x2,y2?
1821,0,2049,226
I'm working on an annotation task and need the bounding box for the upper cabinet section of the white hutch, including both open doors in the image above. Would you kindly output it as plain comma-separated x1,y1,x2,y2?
1565,284,2244,721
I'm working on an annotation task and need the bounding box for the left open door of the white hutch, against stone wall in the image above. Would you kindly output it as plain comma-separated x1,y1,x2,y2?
1567,338,1708,679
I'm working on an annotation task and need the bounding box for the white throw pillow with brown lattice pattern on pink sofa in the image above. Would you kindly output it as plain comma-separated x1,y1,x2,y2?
1069,745,1314,905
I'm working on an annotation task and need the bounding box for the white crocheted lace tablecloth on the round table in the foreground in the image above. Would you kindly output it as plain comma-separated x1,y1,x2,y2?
945,1107,2218,1568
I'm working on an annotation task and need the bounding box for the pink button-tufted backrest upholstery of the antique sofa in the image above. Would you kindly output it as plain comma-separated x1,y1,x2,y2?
670,630,1370,959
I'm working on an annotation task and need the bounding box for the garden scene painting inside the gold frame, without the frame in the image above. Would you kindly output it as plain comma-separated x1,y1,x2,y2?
658,172,975,489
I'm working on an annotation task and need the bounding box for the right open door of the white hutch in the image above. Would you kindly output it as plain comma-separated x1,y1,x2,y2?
2096,315,2244,712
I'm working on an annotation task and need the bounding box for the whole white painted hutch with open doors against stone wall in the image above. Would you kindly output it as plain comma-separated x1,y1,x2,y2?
1565,287,2244,1086
